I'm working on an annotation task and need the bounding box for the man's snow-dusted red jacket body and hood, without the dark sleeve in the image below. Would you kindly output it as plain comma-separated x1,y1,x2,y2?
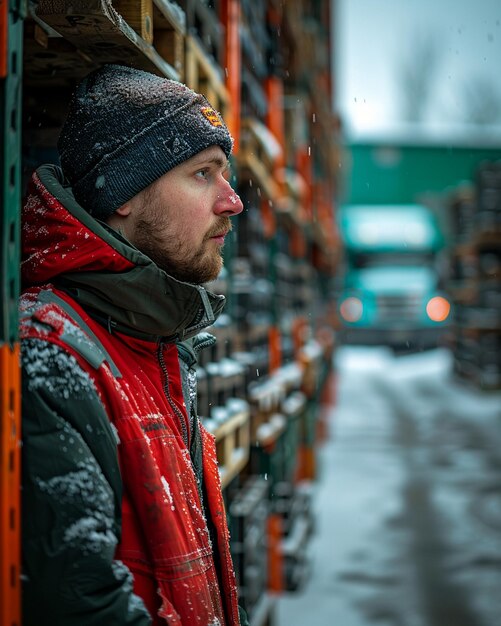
21,168,240,626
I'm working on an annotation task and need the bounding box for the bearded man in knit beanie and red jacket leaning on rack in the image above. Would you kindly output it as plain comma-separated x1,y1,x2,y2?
21,65,244,626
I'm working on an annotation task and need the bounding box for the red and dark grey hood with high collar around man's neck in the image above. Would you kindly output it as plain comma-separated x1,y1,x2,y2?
21,165,225,341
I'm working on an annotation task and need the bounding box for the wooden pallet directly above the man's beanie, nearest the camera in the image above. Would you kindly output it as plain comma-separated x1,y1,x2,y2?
25,0,185,87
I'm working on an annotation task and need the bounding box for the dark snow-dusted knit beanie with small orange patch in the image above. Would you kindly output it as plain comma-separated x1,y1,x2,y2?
57,65,233,220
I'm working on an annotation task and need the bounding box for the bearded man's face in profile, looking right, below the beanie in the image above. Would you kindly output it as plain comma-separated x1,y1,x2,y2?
118,146,243,284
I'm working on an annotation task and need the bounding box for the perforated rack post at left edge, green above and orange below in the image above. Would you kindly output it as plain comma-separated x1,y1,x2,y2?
0,0,26,626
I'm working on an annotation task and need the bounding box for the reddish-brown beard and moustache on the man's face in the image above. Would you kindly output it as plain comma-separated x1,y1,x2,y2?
133,206,231,285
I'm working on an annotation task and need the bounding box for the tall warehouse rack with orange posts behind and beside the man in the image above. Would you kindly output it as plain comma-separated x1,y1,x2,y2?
0,0,339,626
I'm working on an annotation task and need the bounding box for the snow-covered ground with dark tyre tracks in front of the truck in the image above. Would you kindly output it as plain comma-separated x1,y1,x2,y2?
276,348,501,626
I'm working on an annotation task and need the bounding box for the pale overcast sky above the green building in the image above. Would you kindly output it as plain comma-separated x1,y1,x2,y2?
334,0,501,141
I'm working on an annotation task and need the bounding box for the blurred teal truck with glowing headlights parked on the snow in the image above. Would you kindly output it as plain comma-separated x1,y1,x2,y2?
337,204,451,349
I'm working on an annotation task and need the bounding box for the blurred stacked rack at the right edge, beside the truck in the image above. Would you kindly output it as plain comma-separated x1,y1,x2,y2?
448,162,501,390
